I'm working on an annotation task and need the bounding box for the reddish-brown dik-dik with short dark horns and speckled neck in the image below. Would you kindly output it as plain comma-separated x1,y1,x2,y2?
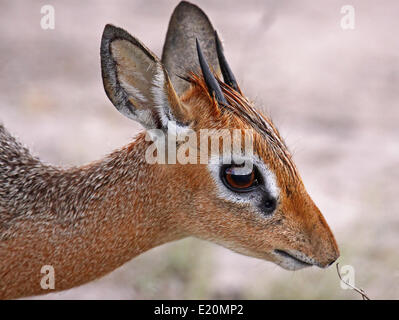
0,2,339,299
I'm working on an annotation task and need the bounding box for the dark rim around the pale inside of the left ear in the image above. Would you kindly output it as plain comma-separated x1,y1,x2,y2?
100,24,189,129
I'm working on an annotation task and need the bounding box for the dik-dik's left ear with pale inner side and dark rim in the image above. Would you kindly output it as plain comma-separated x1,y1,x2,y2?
101,25,188,129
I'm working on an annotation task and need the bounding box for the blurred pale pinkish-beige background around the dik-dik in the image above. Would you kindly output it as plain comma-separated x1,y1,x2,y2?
0,0,399,299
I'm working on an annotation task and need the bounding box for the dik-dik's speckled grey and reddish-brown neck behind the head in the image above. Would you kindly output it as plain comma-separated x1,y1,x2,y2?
0,131,182,298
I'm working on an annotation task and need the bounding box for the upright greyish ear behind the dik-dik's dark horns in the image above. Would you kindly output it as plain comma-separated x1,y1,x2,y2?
162,1,220,95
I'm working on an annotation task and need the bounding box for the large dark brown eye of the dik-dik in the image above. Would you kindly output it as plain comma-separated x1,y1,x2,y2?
221,165,260,192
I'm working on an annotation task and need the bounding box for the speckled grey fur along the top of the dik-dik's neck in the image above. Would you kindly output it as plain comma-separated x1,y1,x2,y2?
0,124,135,241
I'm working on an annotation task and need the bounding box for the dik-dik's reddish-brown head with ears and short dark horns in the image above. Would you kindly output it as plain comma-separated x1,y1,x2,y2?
101,3,339,270
